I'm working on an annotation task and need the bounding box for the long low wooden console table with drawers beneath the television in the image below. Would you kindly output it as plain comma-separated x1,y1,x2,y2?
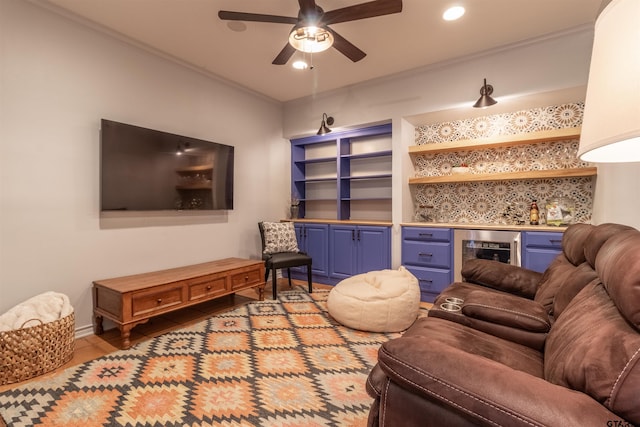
93,258,265,349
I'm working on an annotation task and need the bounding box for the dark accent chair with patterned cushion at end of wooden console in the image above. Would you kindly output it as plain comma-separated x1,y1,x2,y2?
258,222,313,299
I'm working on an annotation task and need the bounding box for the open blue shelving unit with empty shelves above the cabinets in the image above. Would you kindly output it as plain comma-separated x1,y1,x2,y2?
291,124,392,221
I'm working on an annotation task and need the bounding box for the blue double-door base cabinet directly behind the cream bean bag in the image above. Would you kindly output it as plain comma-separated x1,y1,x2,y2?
329,224,391,282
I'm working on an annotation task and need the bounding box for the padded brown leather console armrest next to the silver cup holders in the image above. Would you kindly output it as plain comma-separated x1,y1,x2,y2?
462,290,551,333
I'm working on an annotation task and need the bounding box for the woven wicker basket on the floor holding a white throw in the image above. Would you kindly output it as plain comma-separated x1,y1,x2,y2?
0,312,75,385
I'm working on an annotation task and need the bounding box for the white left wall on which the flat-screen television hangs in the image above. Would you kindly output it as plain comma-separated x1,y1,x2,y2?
0,0,290,328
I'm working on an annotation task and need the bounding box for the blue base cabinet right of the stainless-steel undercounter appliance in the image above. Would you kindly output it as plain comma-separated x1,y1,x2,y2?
522,231,562,273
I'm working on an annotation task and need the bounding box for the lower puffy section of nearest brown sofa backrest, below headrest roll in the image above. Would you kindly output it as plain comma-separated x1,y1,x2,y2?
544,282,640,424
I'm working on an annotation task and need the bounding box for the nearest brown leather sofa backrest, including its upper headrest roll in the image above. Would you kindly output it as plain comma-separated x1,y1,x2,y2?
544,230,640,424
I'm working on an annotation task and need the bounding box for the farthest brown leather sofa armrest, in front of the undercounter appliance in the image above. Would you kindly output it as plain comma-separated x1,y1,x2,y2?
461,259,542,299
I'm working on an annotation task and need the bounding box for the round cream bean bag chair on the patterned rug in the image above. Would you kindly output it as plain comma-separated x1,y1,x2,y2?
327,267,420,332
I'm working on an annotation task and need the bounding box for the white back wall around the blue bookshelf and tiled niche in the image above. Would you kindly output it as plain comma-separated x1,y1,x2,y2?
284,27,640,267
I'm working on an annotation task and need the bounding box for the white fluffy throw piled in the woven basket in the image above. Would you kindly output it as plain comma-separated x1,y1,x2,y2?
0,292,73,331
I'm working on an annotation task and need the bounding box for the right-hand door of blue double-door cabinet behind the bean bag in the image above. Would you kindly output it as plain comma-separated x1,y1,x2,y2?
356,226,391,273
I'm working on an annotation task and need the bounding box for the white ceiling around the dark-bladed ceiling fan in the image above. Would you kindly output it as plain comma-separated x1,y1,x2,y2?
35,0,608,101
